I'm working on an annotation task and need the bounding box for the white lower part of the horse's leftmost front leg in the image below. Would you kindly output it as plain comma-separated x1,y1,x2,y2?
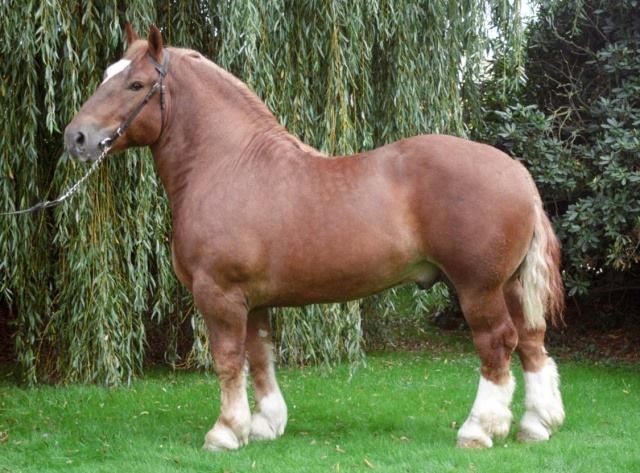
202,370,251,452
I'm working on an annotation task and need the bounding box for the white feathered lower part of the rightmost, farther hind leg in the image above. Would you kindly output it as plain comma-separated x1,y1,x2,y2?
518,358,564,442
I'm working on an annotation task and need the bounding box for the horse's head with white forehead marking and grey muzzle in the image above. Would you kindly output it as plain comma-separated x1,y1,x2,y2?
64,24,168,161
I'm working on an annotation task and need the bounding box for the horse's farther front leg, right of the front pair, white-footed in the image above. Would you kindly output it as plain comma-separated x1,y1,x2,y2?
247,309,287,440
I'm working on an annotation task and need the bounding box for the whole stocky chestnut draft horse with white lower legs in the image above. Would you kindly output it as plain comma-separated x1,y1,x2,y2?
65,25,564,450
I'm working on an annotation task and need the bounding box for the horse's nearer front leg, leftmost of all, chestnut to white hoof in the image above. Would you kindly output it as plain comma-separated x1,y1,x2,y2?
193,279,251,451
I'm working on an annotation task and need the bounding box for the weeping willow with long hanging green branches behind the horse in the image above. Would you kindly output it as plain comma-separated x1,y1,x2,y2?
0,0,519,384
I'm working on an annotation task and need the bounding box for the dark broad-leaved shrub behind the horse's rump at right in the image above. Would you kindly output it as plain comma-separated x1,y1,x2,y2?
474,0,640,330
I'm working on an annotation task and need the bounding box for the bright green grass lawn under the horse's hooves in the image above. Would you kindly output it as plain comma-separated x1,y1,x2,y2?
0,353,640,473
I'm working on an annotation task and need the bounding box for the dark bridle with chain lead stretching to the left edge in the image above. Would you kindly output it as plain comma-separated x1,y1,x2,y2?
0,49,169,215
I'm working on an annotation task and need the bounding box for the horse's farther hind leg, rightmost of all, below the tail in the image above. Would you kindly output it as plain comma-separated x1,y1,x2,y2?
504,280,564,442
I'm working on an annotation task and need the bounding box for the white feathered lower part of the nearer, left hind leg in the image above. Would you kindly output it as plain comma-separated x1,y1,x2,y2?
458,375,516,448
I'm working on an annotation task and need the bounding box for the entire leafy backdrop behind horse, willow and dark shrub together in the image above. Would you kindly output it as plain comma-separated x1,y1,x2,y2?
0,0,640,384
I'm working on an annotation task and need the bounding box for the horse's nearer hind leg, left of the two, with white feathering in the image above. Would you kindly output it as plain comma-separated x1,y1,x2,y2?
458,287,518,448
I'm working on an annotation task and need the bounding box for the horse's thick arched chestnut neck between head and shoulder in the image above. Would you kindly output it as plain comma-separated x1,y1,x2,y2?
152,51,322,209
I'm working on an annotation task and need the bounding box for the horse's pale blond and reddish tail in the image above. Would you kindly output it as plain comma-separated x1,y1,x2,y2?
519,196,564,329
